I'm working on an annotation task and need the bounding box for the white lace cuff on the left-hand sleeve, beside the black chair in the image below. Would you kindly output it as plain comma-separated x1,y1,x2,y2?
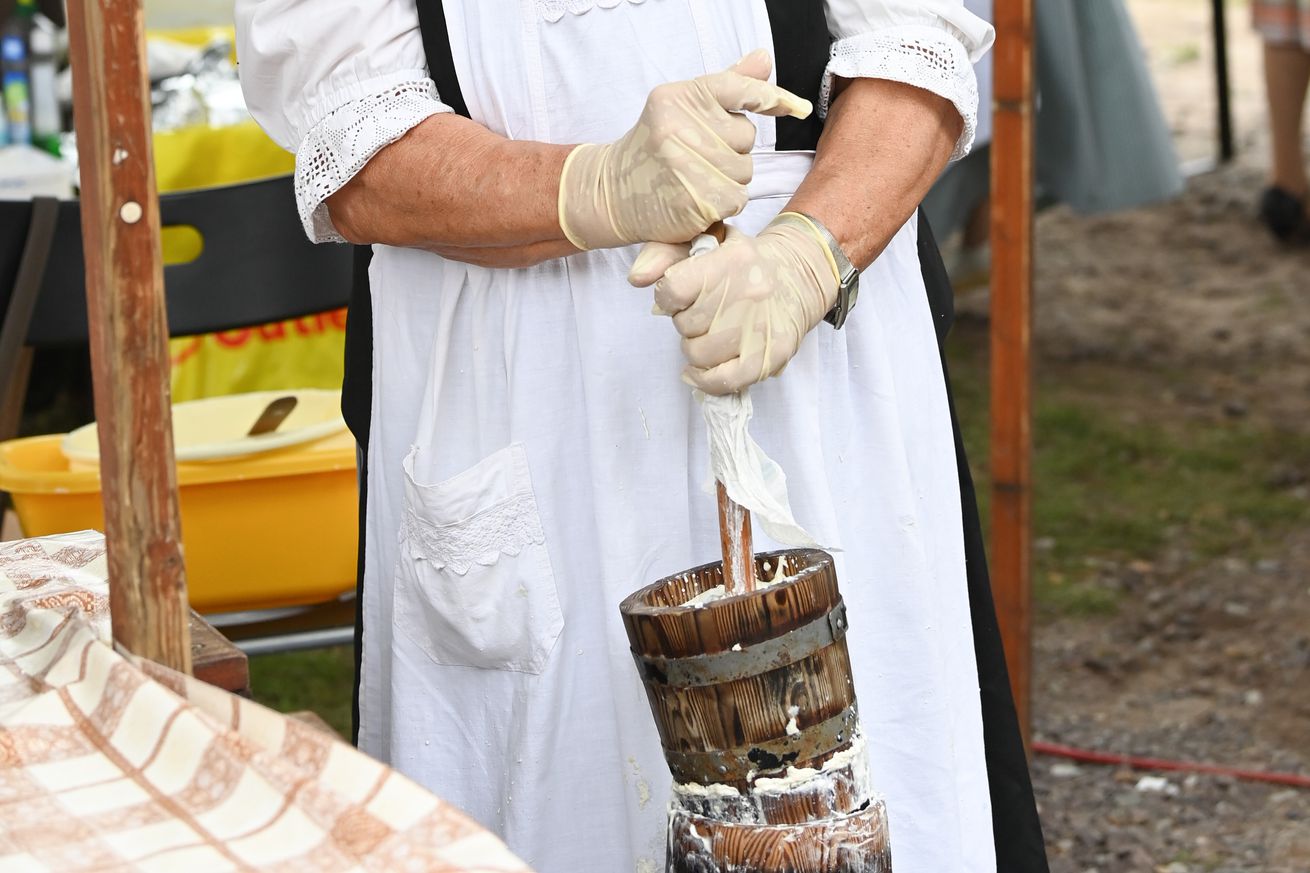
296,73,451,243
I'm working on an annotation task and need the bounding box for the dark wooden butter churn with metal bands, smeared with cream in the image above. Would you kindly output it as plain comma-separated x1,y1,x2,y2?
620,549,892,873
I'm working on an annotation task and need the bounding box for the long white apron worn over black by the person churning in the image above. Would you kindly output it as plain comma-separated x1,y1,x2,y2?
360,0,996,873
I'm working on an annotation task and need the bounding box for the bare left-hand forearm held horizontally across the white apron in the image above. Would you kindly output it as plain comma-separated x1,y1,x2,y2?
328,113,576,255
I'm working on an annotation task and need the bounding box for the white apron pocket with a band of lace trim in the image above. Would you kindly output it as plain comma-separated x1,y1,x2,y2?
396,443,563,674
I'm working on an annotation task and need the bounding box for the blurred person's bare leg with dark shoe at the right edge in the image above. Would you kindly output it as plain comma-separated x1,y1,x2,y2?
1251,0,1310,244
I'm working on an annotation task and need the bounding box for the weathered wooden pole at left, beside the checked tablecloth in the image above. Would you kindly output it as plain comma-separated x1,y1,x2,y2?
68,0,191,672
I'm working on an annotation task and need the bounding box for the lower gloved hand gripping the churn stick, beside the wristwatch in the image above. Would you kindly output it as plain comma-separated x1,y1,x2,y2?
627,212,840,395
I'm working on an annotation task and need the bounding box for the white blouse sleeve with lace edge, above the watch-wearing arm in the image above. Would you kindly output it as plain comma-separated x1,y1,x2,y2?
819,0,994,160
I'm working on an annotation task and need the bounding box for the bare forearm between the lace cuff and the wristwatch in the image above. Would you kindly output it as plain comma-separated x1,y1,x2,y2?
787,79,963,269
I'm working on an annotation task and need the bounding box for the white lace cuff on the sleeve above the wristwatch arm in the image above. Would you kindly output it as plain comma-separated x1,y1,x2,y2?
819,25,979,160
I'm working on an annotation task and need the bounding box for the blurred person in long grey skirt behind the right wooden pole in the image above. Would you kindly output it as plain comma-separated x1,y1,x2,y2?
924,0,1189,285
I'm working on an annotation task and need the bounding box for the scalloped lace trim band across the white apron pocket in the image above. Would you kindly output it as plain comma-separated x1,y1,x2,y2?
401,494,546,575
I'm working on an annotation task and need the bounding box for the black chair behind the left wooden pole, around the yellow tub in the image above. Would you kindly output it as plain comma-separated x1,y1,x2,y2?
0,176,354,653
